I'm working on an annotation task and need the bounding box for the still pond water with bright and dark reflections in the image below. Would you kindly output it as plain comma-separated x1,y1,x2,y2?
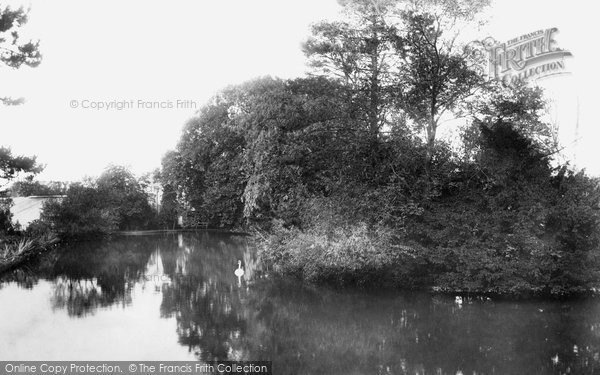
0,233,600,375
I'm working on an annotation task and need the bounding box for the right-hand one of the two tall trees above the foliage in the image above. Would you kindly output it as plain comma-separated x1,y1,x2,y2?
395,10,485,154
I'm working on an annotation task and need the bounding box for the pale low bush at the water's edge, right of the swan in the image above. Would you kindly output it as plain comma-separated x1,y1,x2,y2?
259,222,416,287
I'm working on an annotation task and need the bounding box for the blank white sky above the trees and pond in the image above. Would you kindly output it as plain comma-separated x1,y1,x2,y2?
0,0,600,181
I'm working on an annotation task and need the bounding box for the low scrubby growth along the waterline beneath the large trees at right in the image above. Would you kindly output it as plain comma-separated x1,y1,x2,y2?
255,216,598,297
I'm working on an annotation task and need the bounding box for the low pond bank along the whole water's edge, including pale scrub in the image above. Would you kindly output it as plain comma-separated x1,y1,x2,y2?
0,228,600,300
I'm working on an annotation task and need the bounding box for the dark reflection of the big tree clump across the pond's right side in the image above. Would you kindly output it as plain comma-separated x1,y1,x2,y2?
152,237,600,374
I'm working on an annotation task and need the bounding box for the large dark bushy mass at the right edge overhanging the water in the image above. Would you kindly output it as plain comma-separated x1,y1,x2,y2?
407,122,600,296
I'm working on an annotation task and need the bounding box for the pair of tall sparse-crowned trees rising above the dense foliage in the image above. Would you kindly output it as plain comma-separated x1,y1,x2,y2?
304,0,489,151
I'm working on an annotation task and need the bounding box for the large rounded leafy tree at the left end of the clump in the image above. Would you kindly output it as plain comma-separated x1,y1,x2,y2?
163,78,354,226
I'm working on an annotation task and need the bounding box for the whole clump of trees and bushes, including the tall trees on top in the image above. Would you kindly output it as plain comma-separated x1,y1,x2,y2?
157,0,600,295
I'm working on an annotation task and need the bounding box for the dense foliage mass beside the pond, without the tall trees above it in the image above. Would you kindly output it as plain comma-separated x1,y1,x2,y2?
164,78,600,294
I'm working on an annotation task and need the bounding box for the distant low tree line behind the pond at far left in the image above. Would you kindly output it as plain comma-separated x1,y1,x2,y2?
0,161,164,239
